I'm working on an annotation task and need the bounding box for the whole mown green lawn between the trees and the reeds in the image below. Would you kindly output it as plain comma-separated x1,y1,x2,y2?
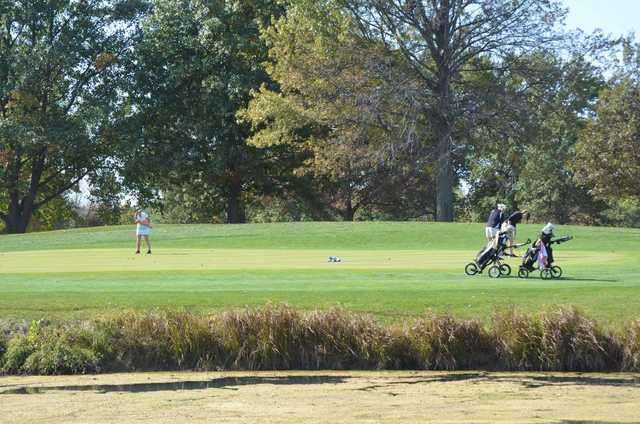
0,222,640,325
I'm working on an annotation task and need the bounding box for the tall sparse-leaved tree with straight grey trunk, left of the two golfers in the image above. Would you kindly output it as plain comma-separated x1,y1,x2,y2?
343,0,564,221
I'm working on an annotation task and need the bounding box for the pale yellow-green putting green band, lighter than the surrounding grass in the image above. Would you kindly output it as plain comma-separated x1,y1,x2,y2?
0,249,628,275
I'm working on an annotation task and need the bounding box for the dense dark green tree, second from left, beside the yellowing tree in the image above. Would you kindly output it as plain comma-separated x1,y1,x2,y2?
121,0,283,223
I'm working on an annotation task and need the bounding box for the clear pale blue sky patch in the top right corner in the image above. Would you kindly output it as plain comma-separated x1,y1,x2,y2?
564,0,640,39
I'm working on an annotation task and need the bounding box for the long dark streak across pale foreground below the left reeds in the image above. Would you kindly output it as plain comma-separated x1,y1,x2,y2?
0,375,346,395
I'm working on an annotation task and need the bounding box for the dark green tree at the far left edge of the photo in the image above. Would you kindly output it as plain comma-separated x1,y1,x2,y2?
0,0,143,233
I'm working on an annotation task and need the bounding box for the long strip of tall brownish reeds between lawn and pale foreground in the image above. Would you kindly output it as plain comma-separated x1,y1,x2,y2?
0,305,640,374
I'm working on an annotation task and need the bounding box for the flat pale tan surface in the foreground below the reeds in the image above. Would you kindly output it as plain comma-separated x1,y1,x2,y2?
0,371,640,424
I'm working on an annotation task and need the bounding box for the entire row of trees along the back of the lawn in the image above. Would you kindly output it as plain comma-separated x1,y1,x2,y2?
0,0,640,233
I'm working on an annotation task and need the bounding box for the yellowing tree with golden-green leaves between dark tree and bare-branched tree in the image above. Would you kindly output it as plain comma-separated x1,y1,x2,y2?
242,1,432,220
